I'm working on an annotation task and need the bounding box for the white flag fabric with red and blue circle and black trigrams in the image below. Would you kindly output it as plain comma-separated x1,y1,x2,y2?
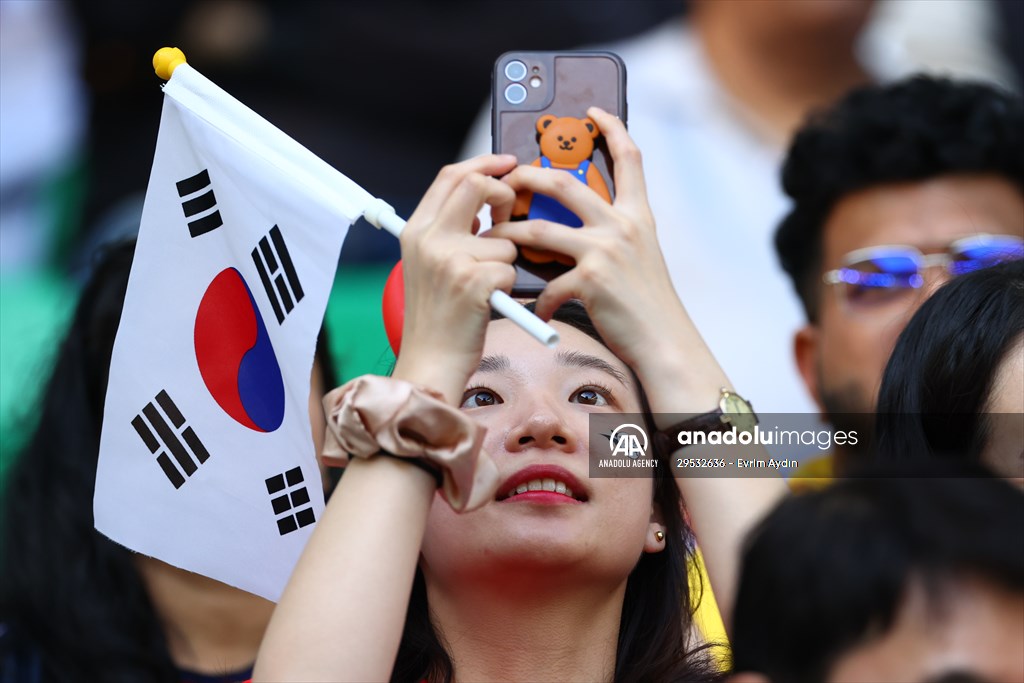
94,65,374,600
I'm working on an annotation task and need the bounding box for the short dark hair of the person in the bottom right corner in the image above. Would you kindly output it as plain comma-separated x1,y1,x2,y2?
732,461,1024,683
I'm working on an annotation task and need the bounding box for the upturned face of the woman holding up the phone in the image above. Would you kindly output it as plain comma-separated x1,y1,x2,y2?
423,321,662,582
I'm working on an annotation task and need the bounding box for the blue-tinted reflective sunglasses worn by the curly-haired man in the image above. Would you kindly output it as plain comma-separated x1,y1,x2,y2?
822,234,1024,307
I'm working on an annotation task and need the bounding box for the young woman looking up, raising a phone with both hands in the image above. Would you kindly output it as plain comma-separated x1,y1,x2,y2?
254,109,784,683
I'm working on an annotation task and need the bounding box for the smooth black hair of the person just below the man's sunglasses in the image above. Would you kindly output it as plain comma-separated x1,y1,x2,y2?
876,261,1024,460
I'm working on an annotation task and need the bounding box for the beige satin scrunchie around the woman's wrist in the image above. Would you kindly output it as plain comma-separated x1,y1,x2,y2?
324,375,499,512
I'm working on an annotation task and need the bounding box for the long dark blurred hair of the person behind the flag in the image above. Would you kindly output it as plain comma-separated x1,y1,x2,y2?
0,241,342,683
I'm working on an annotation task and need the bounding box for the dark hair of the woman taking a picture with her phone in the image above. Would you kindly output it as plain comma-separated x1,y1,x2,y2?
391,301,720,683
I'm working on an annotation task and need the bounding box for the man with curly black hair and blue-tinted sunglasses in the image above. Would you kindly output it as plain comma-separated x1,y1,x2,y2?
775,76,1024,474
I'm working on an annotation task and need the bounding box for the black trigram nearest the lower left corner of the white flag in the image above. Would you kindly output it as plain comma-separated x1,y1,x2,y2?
131,390,210,488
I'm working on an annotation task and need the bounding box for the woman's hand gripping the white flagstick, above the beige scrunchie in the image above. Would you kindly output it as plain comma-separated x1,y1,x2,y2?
393,155,516,405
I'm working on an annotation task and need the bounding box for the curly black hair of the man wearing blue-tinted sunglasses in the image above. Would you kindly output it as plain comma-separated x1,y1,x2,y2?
775,76,1024,322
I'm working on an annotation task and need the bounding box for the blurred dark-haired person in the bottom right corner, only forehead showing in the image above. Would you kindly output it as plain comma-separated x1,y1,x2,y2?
729,461,1024,683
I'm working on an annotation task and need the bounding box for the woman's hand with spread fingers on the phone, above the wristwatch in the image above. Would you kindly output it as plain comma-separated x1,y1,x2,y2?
485,108,725,403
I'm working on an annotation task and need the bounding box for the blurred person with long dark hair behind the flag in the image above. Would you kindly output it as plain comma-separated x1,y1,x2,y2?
0,241,334,683
